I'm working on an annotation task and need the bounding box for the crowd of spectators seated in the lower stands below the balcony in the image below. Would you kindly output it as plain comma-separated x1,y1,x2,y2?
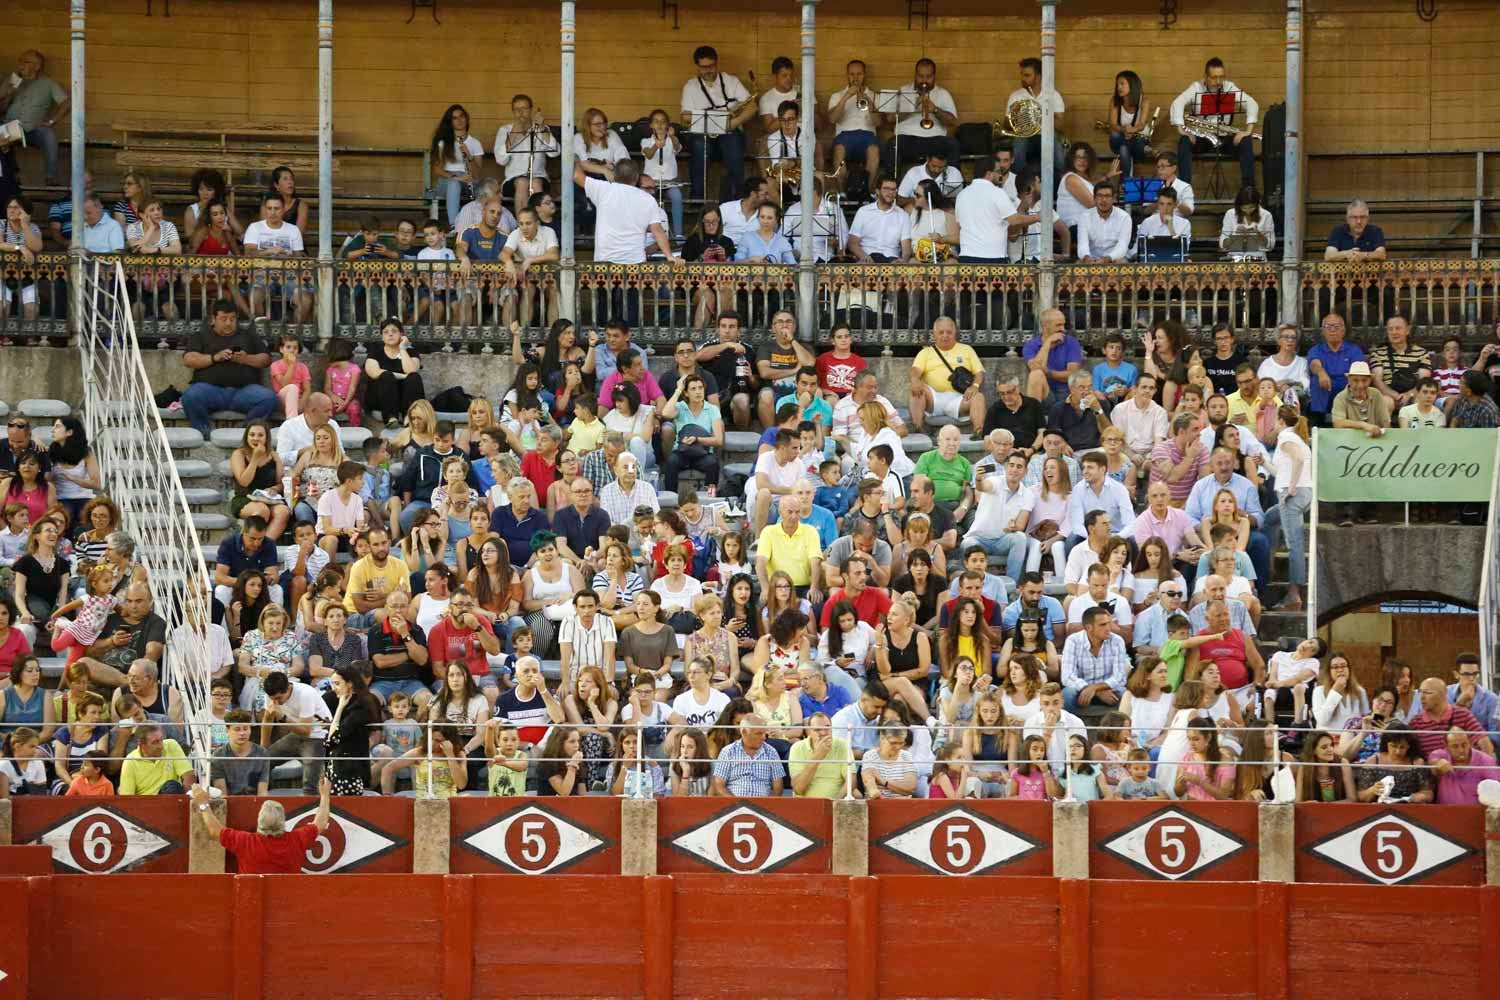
0,290,1497,801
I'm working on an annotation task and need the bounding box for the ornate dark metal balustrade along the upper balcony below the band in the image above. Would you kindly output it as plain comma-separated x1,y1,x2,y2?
0,253,1500,349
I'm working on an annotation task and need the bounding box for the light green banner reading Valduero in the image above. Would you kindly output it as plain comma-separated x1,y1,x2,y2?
1316,427,1500,502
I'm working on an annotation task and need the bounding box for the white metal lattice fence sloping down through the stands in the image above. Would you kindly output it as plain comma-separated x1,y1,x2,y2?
78,259,221,781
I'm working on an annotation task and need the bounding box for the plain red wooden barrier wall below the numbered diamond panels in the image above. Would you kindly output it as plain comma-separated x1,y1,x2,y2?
0,874,1500,1000
